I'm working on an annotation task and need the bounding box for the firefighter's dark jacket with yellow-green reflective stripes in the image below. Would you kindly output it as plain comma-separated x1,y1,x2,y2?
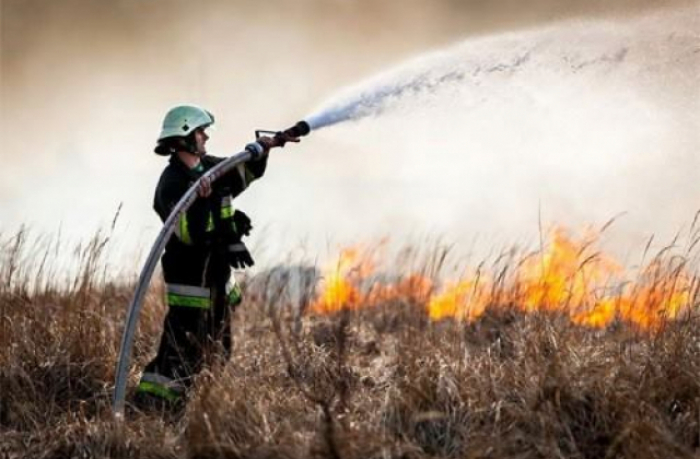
153,155,267,309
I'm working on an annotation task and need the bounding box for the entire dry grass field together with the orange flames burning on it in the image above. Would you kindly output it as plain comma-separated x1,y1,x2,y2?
0,230,700,459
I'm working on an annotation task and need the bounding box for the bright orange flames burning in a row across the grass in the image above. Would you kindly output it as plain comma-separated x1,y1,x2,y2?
312,227,696,330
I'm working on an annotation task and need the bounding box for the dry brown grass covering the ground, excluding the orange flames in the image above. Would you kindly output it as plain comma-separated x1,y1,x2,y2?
0,228,700,459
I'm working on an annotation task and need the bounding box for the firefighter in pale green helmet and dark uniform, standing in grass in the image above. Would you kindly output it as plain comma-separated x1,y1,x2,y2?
137,105,296,406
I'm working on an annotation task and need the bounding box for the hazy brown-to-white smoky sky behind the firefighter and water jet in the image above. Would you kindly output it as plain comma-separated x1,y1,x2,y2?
0,0,700,270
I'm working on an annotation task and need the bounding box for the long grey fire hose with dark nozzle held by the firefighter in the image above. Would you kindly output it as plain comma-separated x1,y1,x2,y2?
112,121,311,417
